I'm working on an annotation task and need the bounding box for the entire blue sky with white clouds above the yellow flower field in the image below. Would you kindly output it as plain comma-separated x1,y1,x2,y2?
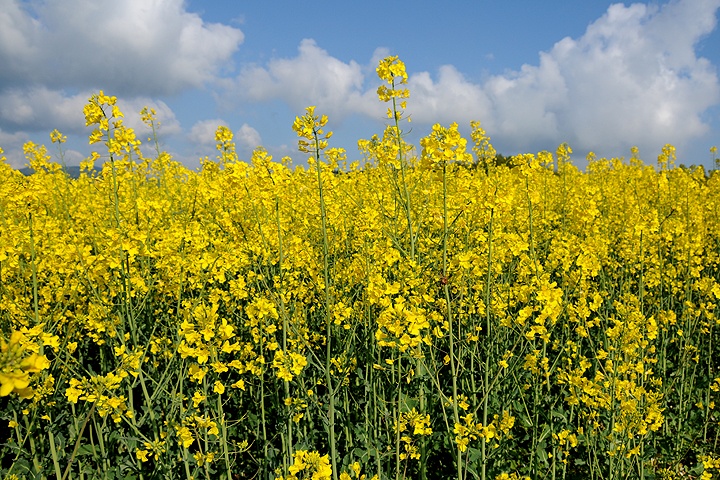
0,0,720,168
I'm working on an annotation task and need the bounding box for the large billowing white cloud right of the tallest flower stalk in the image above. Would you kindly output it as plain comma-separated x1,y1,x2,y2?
402,0,720,154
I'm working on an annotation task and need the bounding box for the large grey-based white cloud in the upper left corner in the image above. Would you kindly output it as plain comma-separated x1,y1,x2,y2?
0,0,243,163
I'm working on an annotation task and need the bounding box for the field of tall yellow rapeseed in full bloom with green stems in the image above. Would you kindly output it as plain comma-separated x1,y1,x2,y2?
0,57,720,480
